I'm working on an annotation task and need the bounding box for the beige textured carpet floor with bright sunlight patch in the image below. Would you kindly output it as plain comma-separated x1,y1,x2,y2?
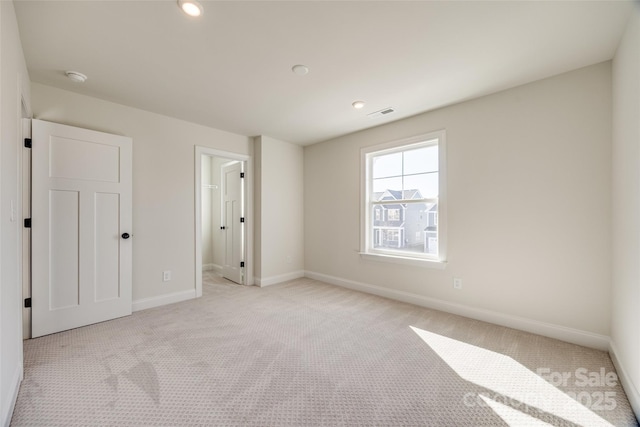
11,273,637,427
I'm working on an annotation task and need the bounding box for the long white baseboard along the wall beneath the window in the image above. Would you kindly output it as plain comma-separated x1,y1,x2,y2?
305,271,609,351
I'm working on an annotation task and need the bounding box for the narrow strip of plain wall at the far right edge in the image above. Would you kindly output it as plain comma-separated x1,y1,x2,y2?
611,8,640,418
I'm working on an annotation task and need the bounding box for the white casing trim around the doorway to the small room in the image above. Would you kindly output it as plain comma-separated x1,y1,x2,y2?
194,145,253,298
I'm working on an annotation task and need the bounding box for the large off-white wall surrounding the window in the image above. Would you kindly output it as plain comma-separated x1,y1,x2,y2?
304,62,611,348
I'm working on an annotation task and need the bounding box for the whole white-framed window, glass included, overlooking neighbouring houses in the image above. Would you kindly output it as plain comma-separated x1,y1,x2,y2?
361,131,446,262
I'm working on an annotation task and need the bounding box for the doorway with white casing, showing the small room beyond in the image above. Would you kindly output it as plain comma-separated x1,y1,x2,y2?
195,147,253,297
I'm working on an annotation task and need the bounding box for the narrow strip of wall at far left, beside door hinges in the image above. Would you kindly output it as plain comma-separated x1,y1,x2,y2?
0,1,30,426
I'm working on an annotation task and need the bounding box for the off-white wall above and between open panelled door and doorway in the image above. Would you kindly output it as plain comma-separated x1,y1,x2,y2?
32,83,252,308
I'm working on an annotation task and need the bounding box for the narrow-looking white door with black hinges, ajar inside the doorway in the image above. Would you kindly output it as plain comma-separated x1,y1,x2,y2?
222,162,244,284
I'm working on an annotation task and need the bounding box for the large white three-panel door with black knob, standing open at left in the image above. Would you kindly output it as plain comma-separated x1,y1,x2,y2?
31,120,132,338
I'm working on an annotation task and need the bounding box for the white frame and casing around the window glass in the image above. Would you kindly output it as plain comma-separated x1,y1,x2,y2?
360,129,447,269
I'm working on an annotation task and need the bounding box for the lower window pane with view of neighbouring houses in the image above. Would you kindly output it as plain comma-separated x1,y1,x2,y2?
371,203,438,255
